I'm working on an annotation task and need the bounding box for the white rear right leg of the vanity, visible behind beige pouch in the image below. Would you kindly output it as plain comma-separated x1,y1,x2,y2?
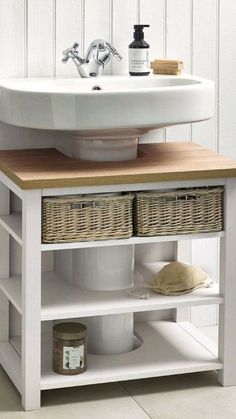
174,240,191,323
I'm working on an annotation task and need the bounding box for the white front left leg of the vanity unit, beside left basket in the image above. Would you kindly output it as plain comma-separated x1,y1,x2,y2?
22,190,41,410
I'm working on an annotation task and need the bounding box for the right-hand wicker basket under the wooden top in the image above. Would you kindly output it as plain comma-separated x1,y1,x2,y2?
134,187,224,236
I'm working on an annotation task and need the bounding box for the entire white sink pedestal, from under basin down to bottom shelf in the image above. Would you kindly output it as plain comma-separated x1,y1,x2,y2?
73,139,137,354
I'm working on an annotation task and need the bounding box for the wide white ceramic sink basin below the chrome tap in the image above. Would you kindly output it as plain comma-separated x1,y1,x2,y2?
0,75,215,137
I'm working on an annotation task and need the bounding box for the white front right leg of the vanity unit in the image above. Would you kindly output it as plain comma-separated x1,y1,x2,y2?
219,178,236,386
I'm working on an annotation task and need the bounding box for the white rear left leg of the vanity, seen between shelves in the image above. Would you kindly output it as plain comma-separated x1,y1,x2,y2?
0,183,10,342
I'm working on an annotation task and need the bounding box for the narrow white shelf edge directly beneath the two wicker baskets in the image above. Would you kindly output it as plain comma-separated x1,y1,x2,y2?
41,231,224,252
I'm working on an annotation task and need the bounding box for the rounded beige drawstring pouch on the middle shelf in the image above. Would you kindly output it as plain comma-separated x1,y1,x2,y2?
151,262,211,295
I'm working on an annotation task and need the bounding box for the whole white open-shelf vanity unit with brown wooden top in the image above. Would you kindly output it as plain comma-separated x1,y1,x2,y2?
0,143,236,410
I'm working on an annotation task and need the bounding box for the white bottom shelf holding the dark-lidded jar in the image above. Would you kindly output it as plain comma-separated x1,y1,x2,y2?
6,321,223,390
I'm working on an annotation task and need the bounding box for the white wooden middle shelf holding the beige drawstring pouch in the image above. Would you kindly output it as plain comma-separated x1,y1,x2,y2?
0,262,224,321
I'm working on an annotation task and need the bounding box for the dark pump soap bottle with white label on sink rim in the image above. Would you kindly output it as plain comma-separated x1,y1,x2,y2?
129,25,150,76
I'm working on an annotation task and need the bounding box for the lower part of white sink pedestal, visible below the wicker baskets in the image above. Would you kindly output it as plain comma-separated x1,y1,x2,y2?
73,246,134,354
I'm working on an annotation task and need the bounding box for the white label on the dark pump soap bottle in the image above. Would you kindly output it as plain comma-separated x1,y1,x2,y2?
129,48,150,73
